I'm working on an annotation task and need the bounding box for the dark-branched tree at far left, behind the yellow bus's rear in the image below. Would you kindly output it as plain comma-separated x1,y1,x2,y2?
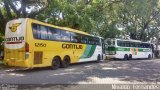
0,0,50,34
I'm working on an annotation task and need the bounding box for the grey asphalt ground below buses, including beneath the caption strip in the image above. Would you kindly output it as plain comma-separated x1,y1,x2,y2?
0,59,160,90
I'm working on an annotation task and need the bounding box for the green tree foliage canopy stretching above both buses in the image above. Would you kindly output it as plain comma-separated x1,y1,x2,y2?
0,0,160,41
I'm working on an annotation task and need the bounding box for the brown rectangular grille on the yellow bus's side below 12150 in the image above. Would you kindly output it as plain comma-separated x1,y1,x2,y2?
34,51,43,64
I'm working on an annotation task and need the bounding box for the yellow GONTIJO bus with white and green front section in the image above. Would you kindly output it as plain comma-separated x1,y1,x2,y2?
4,18,104,69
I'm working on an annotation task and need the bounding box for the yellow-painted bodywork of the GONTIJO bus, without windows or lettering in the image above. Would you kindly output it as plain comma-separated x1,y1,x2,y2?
4,19,95,68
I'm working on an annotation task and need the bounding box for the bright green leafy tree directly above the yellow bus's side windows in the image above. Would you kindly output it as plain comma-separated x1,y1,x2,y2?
37,0,120,38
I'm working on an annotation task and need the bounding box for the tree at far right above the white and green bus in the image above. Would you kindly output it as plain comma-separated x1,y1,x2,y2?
119,0,160,41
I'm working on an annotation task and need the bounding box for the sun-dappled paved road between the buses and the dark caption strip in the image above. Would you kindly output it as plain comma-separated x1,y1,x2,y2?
0,59,160,85
